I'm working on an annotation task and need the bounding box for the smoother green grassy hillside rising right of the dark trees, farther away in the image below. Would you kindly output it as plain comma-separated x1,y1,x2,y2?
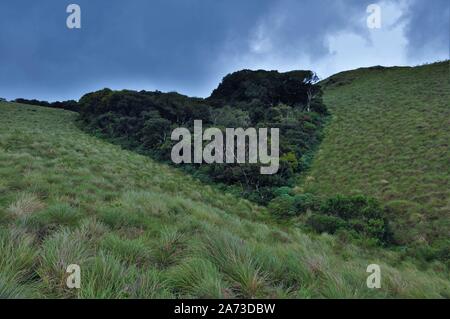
304,61,450,251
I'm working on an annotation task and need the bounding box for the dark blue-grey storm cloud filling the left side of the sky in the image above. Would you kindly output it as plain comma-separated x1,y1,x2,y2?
0,0,268,98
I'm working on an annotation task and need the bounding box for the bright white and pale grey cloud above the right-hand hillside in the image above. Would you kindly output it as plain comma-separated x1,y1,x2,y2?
218,0,446,82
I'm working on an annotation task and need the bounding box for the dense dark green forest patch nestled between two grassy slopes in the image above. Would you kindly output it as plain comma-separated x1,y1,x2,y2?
78,70,327,204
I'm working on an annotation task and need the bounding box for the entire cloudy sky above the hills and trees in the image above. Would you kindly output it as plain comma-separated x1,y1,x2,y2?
0,0,450,101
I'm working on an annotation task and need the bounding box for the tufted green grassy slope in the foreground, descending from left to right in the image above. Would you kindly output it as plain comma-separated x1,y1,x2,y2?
0,103,450,298
